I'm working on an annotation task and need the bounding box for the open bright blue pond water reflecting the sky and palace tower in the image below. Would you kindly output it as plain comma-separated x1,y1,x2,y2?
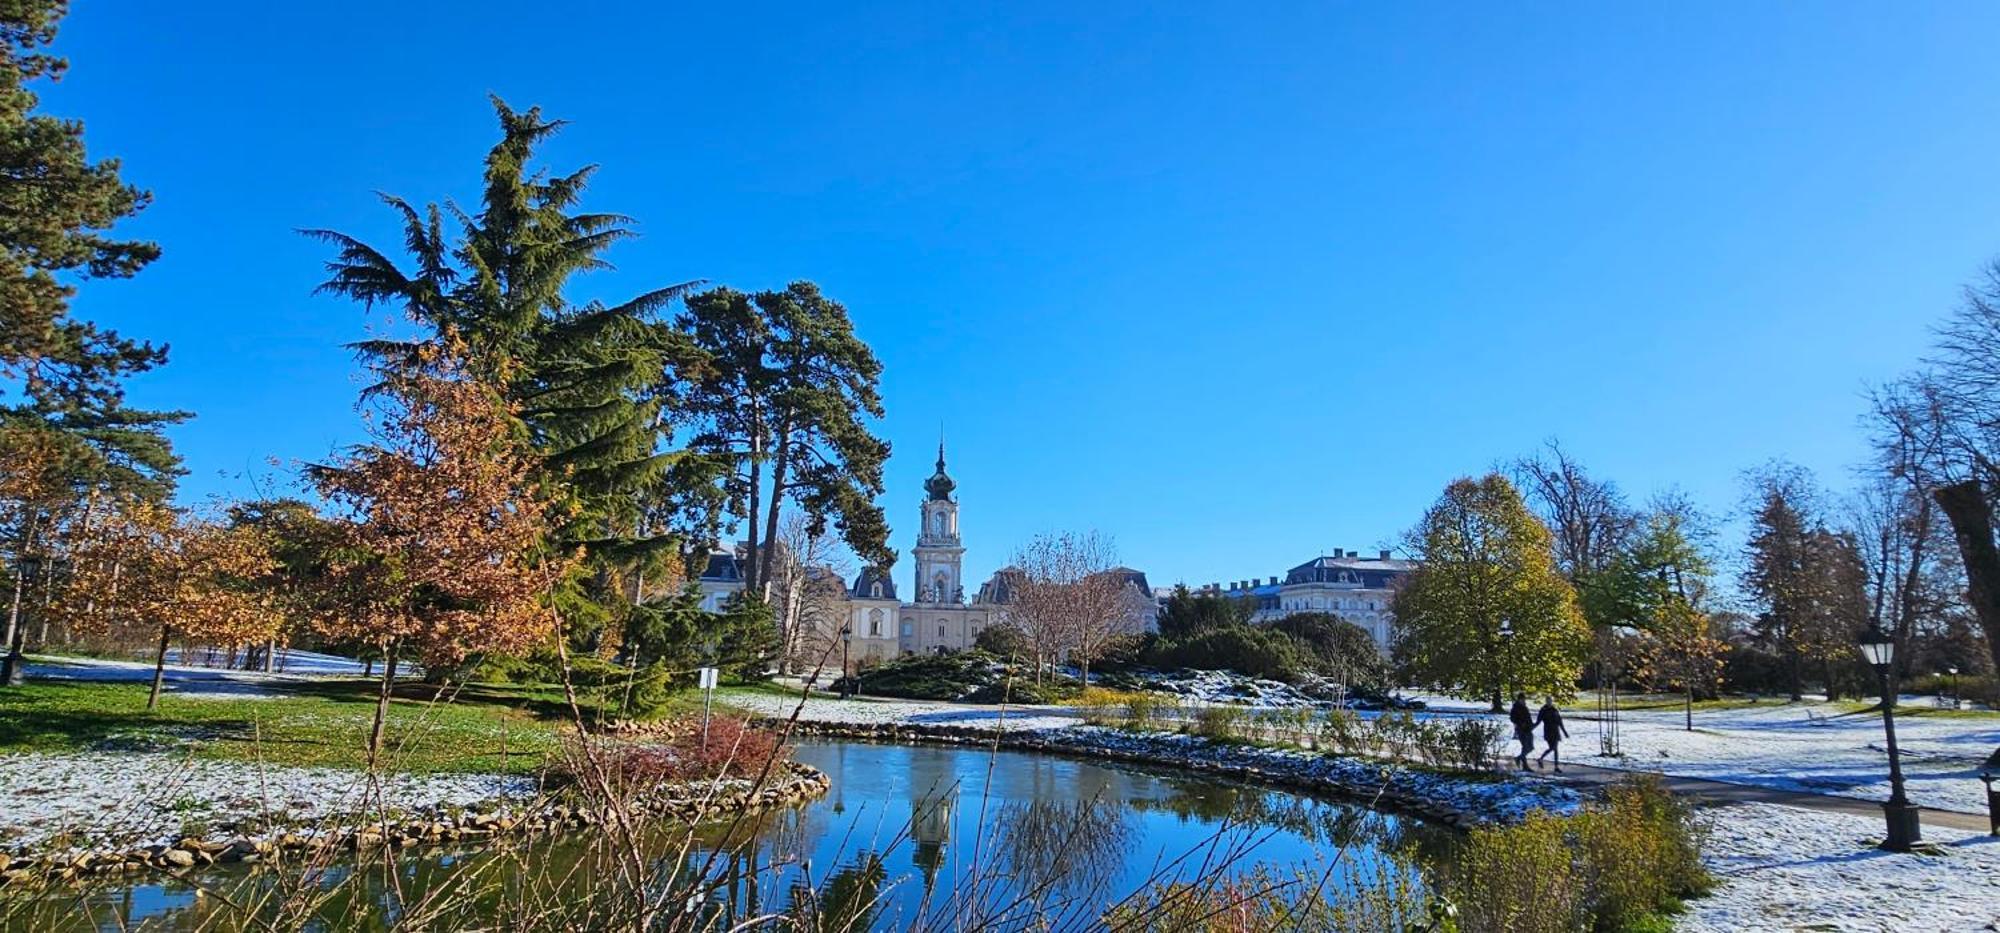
798,745,1432,927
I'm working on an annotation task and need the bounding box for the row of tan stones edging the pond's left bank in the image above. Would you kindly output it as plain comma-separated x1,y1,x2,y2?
0,761,832,889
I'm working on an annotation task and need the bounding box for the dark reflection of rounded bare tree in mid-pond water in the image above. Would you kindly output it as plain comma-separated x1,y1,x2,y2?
996,797,1138,893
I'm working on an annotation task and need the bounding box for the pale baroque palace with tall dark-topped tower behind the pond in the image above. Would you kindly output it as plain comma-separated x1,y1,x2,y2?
700,444,1152,665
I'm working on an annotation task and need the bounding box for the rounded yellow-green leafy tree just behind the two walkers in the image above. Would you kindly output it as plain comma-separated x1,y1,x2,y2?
1396,475,1590,711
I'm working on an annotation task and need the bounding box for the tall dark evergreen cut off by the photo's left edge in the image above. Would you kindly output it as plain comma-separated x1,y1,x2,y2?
0,0,186,683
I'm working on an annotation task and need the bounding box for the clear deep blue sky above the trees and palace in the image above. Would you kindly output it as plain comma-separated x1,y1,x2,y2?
46,0,2000,583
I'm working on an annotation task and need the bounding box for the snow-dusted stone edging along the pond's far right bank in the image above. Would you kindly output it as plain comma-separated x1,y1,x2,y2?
752,719,1576,831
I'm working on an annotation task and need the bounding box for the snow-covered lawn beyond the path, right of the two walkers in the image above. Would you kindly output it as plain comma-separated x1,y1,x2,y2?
1566,699,2000,813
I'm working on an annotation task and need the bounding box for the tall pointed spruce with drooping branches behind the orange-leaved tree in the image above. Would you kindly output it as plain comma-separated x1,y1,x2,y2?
308,98,702,647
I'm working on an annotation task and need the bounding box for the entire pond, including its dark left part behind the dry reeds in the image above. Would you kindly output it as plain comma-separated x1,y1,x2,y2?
0,743,1454,931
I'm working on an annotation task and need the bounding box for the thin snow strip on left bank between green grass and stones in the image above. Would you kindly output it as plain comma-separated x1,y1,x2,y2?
0,751,536,851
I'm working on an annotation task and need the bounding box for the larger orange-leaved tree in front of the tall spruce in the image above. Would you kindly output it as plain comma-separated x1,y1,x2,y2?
310,350,576,763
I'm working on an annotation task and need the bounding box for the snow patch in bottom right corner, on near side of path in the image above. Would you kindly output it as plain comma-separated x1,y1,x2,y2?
1674,803,2000,933
